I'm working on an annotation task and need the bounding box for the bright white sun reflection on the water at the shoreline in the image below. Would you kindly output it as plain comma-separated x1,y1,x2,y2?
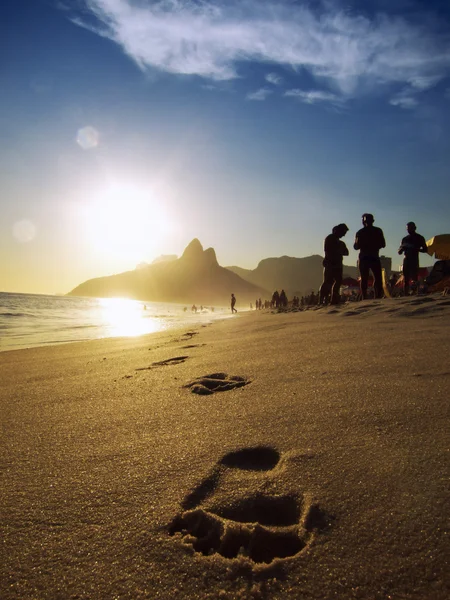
99,298,165,337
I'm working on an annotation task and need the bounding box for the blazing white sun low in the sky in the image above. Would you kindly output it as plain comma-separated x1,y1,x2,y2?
86,185,169,262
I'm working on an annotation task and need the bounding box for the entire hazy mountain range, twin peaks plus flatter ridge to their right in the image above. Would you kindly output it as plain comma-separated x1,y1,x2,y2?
69,238,356,306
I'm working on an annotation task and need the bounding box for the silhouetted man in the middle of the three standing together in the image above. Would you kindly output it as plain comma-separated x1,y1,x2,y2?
353,213,386,300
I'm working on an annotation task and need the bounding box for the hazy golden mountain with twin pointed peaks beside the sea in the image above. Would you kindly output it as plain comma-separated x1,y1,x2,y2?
68,239,269,307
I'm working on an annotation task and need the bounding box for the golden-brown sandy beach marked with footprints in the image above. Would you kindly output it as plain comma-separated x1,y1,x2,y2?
0,295,450,600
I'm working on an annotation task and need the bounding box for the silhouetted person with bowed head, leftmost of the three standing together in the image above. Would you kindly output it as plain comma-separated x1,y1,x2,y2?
319,223,348,304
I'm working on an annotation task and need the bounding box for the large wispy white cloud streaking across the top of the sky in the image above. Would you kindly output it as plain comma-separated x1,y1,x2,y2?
74,0,450,101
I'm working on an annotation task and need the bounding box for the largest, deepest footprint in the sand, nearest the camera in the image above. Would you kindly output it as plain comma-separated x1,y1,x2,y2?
169,446,327,569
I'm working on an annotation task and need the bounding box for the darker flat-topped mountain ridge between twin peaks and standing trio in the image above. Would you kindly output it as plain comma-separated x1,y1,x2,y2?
227,254,358,298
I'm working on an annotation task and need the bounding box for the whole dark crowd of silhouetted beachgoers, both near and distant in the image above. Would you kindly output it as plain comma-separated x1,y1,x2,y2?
231,213,427,312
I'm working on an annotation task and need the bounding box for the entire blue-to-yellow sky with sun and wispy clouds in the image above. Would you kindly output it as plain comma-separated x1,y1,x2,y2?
0,0,450,294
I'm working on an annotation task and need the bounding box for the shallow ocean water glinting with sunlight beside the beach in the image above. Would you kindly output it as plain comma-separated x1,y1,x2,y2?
0,292,230,351
